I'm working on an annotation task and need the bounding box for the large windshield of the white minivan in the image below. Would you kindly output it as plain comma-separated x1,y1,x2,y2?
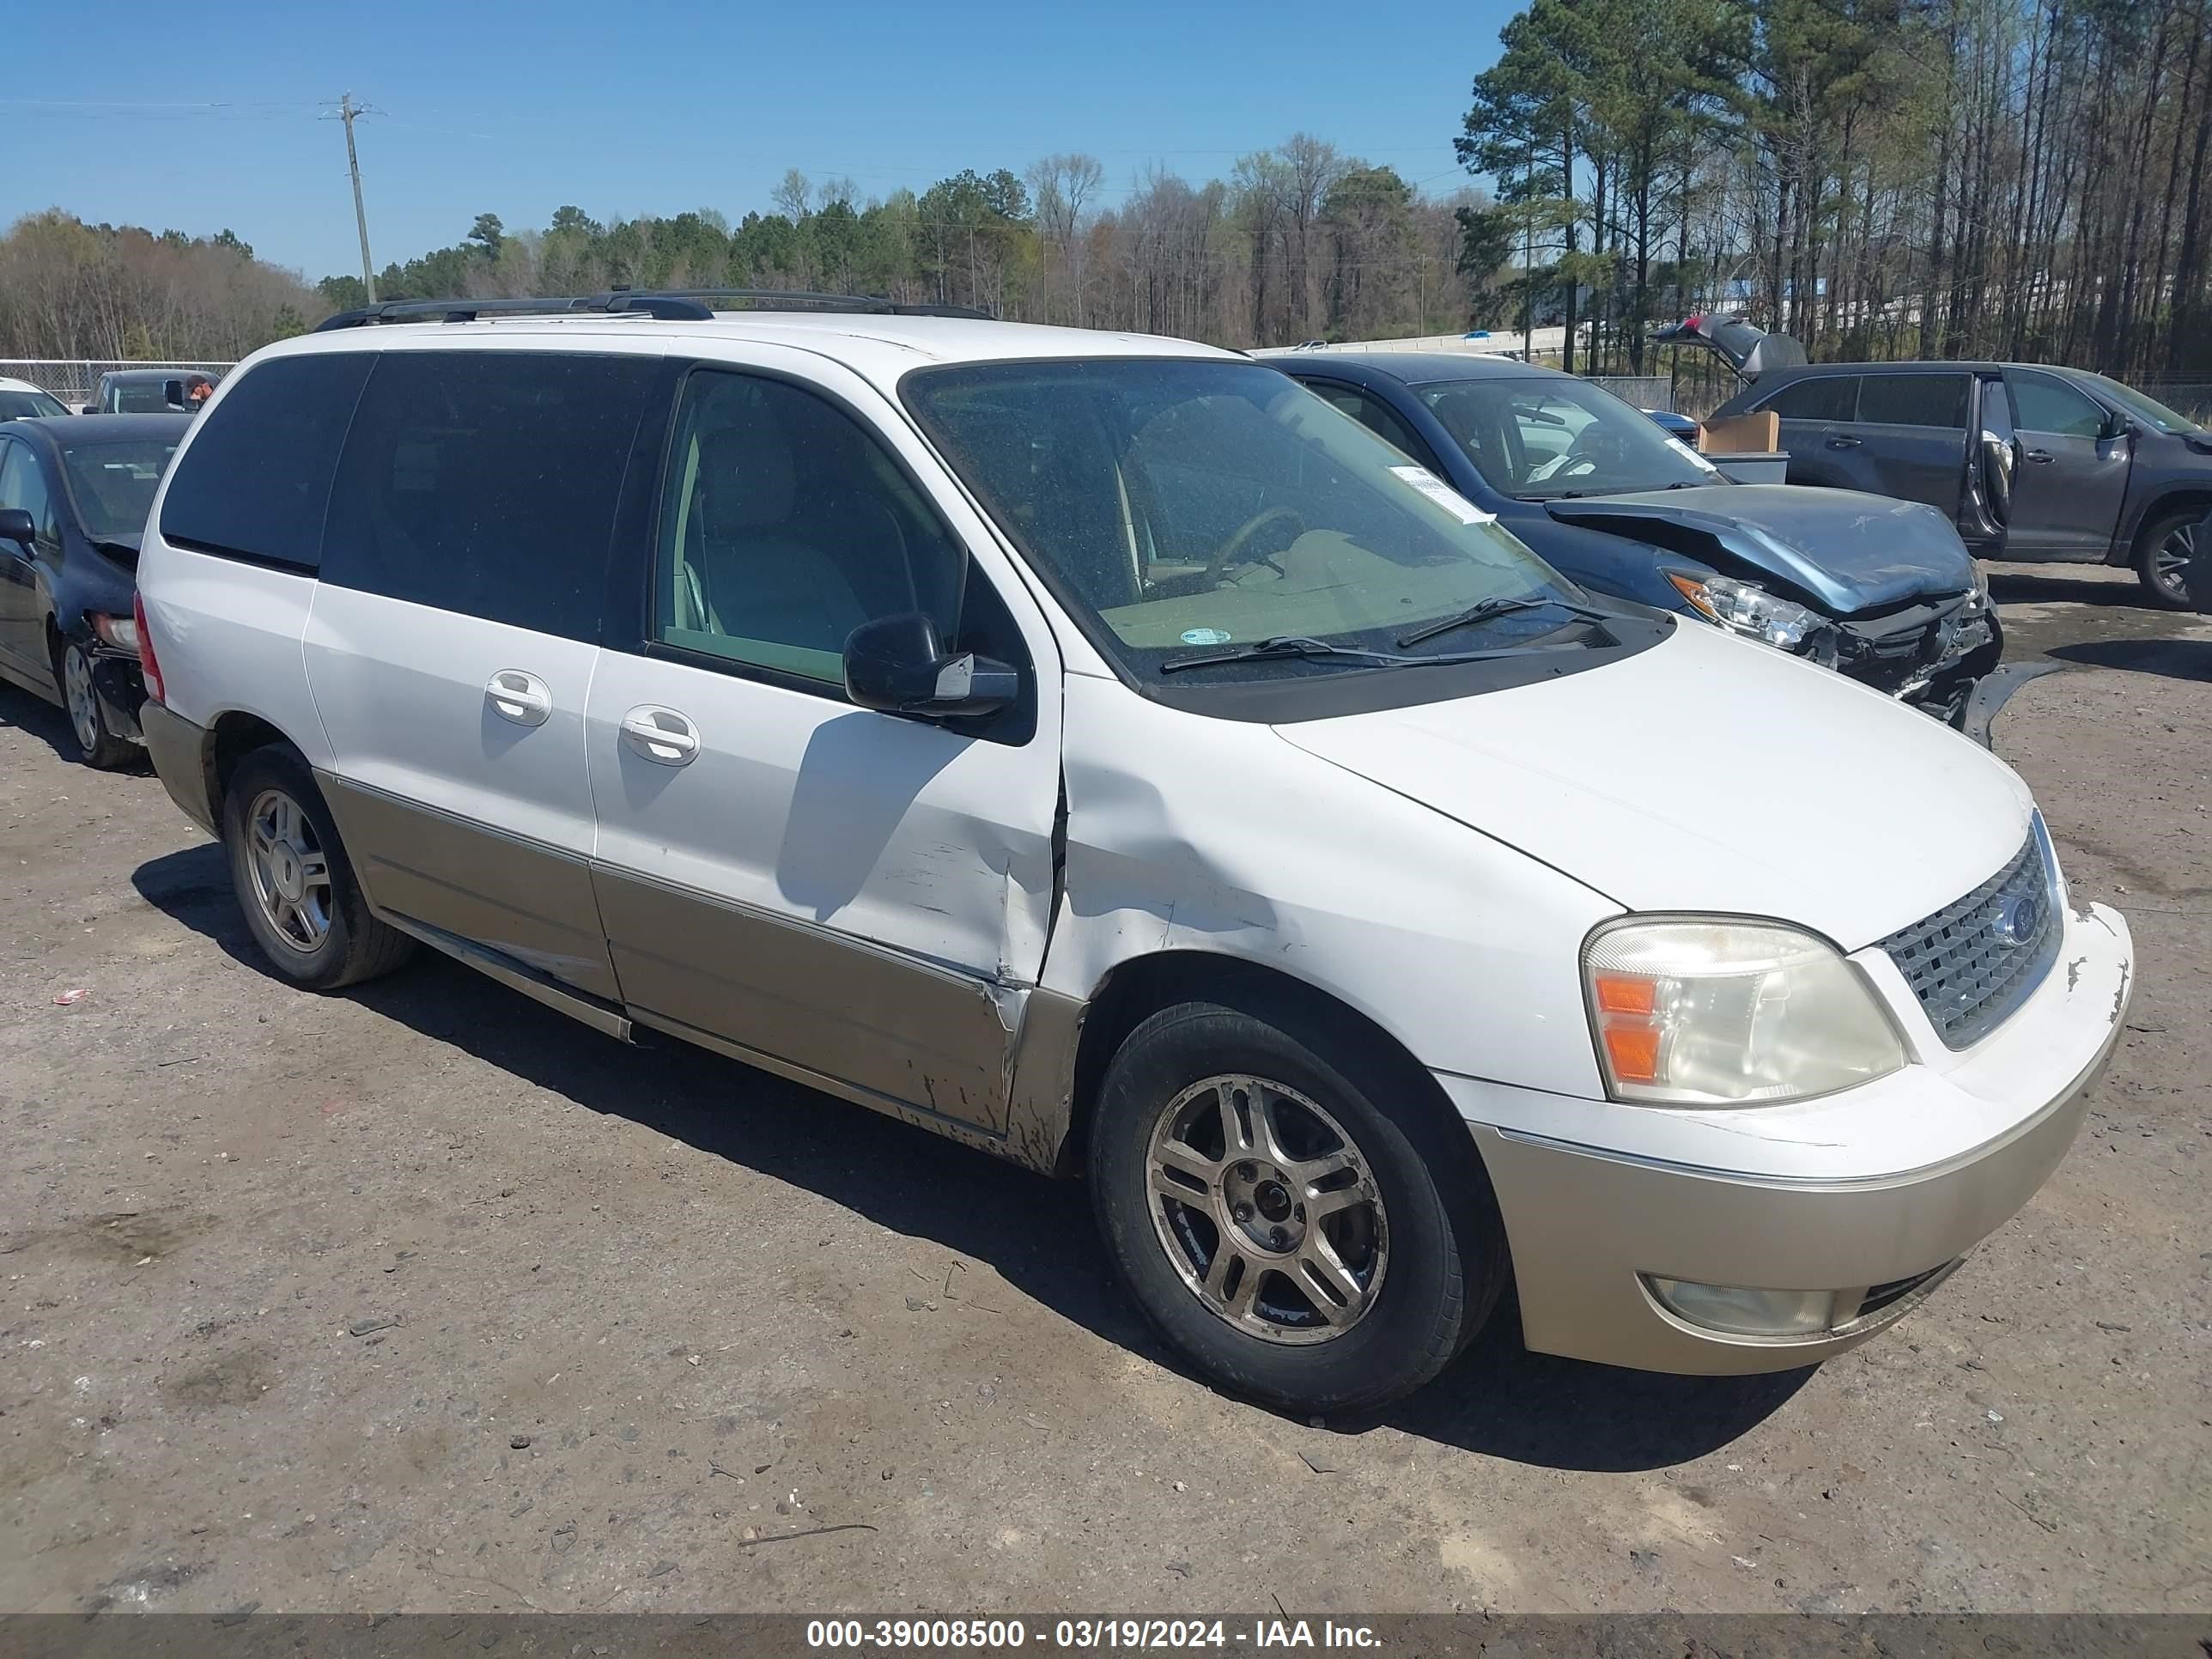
905,358,1577,679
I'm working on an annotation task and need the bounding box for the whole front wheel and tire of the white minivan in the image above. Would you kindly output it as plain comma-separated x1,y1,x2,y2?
1091,1002,1509,1413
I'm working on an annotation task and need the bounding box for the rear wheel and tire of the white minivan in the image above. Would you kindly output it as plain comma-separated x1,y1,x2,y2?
223,744,416,991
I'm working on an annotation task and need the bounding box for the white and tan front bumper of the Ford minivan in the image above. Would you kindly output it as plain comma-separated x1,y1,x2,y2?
1437,905,2135,1376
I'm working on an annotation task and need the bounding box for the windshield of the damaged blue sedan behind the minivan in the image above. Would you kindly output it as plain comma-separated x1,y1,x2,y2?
1416,374,1721,500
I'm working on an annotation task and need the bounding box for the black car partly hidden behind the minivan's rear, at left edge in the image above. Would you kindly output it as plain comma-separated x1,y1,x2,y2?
0,416,192,768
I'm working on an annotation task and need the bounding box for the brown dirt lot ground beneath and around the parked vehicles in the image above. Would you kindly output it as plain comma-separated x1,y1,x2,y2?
0,573,2212,1614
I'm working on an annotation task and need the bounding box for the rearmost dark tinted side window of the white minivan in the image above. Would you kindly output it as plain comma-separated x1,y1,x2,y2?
161,352,374,571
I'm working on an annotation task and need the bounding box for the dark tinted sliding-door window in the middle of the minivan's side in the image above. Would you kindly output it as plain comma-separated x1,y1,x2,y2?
323,352,657,639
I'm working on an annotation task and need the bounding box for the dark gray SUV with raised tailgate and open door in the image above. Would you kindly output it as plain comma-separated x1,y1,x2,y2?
1719,362,2212,611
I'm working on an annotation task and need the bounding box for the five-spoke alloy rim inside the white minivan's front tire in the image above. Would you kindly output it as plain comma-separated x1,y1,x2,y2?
1146,1075,1389,1343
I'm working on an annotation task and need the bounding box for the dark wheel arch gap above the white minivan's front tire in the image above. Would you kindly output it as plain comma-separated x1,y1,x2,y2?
1053,951,1486,1182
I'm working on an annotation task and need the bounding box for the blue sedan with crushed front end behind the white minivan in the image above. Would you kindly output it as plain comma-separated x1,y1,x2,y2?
1265,349,2004,723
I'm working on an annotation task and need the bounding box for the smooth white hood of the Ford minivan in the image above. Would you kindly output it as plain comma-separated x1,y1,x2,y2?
1276,623,2033,951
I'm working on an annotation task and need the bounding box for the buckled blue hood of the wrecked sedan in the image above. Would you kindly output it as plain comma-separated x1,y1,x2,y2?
1544,484,1973,617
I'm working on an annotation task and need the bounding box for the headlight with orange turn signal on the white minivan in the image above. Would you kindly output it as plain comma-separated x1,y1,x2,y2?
1582,918,1905,1106
